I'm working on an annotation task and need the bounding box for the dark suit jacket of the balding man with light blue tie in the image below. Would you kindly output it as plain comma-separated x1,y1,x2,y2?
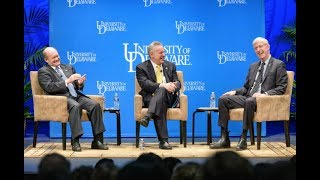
38,64,85,97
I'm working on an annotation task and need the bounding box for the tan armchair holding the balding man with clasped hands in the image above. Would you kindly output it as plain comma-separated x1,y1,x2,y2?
30,71,104,150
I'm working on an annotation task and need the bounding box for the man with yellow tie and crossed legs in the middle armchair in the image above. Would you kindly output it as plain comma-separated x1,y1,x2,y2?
136,41,181,149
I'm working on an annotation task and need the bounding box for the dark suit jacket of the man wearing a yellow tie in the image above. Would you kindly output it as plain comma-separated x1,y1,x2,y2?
136,60,181,106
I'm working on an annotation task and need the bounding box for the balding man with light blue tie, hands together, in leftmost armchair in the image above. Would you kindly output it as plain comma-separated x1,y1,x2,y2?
38,47,109,151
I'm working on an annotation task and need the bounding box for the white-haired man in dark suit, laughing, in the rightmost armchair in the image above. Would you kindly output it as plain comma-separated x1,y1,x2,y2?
210,37,288,150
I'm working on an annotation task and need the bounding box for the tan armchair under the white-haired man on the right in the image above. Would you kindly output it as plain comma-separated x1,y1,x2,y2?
229,71,294,150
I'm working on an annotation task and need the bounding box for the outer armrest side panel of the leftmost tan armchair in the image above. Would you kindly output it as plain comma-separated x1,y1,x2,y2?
33,95,68,122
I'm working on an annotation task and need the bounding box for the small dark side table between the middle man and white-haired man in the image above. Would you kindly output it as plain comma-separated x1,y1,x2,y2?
192,107,218,145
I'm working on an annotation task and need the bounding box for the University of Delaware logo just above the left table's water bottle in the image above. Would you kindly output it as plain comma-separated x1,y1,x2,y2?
97,81,127,96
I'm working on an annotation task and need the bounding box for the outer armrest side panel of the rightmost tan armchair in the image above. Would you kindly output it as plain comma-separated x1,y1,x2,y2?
255,95,291,122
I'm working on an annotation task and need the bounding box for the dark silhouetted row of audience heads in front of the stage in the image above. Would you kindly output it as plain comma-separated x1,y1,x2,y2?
32,150,296,180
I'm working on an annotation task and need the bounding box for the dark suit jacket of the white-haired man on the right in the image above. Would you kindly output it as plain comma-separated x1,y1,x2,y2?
236,57,288,95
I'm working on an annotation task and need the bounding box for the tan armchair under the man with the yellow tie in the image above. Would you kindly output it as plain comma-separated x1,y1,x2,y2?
134,71,188,148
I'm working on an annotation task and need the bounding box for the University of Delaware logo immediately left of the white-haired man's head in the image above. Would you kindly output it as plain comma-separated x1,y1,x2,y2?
217,51,247,64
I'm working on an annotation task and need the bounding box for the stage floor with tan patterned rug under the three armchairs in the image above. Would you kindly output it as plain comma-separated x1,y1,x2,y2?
24,133,296,174
